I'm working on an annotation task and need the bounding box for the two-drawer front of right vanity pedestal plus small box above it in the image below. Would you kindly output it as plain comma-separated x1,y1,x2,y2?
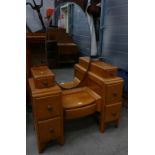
90,61,123,125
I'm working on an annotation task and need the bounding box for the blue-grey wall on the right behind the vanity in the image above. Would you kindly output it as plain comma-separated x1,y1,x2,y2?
102,0,128,70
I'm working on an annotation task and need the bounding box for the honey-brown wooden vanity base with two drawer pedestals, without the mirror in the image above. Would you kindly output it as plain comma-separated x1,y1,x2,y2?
29,57,123,153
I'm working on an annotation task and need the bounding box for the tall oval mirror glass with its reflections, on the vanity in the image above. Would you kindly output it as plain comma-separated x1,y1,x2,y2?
47,3,91,88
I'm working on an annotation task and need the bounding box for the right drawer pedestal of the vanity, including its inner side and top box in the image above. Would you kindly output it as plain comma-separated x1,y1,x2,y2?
80,57,123,130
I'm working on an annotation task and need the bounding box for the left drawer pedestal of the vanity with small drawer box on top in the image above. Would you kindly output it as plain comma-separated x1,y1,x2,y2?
29,67,64,153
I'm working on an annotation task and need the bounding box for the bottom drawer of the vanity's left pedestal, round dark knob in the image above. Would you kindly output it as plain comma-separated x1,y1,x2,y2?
38,117,62,143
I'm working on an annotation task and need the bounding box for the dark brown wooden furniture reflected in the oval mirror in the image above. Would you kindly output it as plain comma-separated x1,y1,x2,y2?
47,27,78,65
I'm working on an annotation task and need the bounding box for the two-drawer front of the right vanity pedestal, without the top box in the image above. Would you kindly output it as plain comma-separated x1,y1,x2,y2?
104,77,123,126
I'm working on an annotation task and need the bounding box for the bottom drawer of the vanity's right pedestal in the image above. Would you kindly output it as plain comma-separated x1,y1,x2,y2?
105,103,122,122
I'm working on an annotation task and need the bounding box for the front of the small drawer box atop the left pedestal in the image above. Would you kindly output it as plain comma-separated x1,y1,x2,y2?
35,77,54,89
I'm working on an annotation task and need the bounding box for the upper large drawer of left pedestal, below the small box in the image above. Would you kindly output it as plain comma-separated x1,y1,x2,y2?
34,95,62,120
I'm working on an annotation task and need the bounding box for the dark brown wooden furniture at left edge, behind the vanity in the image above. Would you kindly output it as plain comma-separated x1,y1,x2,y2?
26,32,47,107
